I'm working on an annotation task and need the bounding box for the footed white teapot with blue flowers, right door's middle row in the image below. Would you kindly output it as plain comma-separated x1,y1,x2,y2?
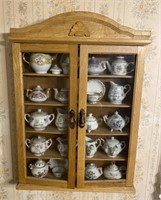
103,111,130,132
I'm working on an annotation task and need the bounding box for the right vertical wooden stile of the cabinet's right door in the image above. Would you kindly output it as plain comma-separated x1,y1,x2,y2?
126,47,144,186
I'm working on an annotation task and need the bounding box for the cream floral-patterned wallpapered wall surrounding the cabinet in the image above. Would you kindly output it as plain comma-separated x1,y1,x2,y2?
0,0,161,200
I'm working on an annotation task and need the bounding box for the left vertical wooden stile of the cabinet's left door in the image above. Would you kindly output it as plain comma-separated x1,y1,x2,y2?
12,43,26,183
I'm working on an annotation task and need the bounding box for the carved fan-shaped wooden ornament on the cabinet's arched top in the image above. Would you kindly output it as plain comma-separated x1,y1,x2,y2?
68,21,90,37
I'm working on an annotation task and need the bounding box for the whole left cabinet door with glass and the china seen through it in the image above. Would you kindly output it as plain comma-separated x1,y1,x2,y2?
13,44,78,188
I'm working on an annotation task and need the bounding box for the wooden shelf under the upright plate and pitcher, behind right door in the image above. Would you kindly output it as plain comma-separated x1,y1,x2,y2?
87,101,131,108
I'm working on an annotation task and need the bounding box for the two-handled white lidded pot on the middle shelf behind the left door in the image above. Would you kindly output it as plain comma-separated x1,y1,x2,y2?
24,109,55,131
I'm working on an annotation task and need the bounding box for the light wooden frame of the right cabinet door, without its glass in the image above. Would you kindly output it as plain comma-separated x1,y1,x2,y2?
77,45,144,188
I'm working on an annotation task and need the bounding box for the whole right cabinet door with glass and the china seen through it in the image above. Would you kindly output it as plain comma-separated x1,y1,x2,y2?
77,45,142,188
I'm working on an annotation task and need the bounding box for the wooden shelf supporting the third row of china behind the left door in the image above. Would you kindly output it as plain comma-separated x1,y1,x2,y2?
25,125,68,135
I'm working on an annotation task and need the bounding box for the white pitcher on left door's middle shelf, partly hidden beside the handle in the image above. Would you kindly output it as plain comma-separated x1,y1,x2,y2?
55,108,68,131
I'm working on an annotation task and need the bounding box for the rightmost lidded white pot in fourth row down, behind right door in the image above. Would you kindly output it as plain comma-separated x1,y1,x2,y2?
101,137,126,158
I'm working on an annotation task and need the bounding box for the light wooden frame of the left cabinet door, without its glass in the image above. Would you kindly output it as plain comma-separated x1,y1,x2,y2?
13,43,78,188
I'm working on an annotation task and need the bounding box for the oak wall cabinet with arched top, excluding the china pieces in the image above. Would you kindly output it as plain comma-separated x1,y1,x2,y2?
9,12,151,192
